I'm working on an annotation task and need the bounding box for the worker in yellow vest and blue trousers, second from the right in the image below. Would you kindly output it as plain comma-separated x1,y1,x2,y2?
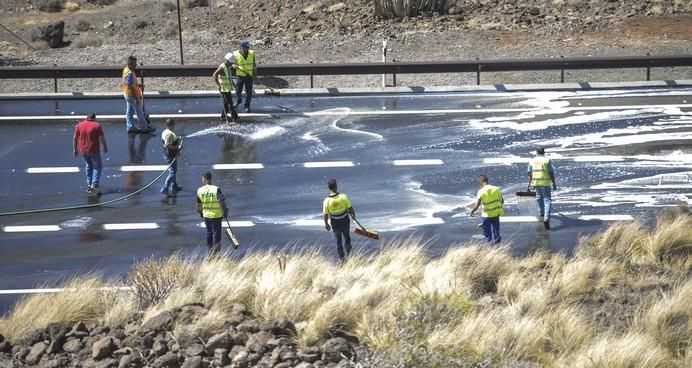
469,175,505,244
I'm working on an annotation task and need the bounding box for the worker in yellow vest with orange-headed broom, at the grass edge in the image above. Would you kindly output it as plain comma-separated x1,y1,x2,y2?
322,179,379,262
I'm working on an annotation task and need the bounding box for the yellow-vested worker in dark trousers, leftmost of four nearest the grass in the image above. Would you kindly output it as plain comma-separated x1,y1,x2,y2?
197,171,228,256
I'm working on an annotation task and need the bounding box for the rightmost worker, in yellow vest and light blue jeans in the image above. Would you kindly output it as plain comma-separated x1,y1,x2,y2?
528,147,557,230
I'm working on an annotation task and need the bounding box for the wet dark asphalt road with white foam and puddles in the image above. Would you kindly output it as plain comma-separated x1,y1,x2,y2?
0,88,692,309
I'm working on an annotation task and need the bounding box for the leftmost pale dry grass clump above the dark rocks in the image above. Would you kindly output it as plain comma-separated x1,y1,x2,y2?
0,276,123,343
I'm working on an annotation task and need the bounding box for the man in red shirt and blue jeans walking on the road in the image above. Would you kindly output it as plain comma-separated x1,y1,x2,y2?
72,112,108,195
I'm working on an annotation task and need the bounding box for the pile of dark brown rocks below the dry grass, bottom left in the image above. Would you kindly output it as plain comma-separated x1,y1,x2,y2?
0,304,356,368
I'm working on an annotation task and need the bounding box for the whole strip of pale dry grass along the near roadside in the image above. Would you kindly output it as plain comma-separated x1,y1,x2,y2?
0,207,692,367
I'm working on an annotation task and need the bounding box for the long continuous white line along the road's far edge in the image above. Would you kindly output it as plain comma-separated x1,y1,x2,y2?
0,104,690,121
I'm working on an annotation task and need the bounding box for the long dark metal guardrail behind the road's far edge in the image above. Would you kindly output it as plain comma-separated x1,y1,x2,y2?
0,55,692,92
